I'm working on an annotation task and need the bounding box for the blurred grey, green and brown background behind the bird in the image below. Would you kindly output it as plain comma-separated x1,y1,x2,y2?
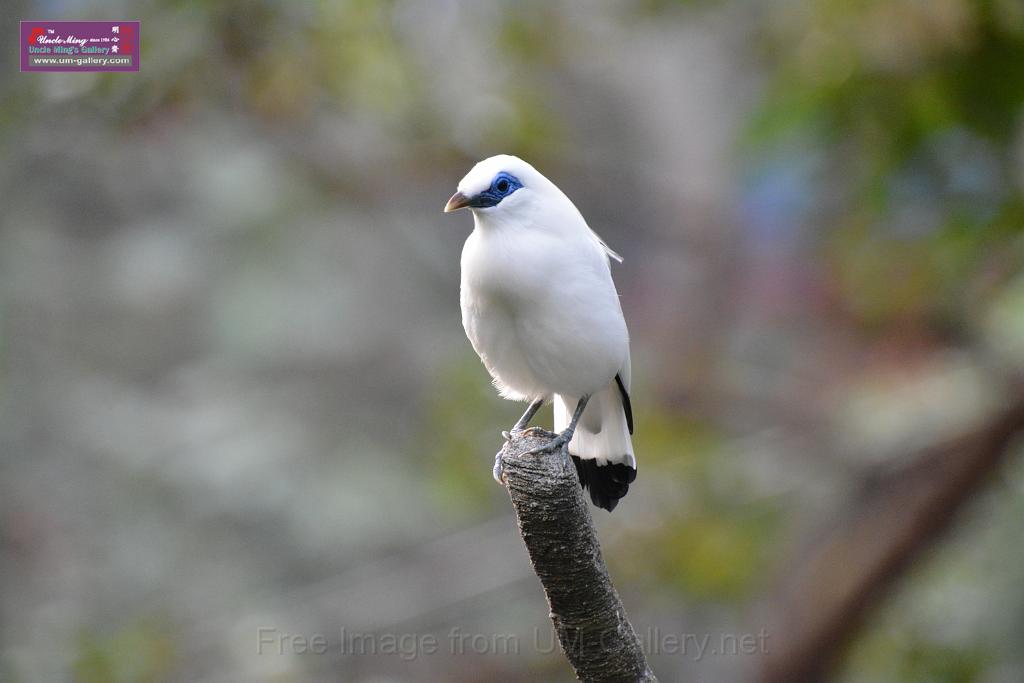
6,0,1024,683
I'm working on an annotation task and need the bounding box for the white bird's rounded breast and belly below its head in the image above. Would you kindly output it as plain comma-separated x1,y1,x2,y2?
461,209,629,398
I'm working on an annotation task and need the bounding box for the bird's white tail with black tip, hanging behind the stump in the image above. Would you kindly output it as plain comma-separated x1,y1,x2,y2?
554,382,637,512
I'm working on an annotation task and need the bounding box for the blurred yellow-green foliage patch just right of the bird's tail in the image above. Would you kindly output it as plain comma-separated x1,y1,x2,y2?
609,407,783,602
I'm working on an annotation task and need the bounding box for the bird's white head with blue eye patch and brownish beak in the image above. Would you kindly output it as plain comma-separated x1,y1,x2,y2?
444,155,545,213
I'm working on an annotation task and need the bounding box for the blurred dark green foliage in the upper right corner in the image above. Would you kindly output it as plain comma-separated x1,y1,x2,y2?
748,0,1024,326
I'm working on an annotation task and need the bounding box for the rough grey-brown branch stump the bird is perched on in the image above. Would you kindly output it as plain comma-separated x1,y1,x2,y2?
501,436,657,683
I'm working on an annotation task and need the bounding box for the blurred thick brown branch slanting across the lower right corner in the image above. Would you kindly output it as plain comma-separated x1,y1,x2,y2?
761,392,1024,683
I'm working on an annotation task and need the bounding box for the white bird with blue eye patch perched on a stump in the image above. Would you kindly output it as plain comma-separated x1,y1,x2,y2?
444,155,636,511
